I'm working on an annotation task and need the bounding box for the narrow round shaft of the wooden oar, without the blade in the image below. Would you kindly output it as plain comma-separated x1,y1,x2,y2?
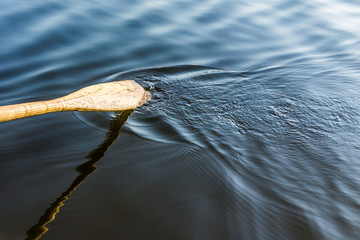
0,100,64,122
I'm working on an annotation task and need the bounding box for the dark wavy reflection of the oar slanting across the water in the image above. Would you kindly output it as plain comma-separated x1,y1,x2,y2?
26,110,133,240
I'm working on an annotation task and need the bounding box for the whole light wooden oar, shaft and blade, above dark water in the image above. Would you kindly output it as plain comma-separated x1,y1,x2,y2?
0,80,151,122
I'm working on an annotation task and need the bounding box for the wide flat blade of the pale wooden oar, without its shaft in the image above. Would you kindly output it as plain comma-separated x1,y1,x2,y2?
56,80,151,111
